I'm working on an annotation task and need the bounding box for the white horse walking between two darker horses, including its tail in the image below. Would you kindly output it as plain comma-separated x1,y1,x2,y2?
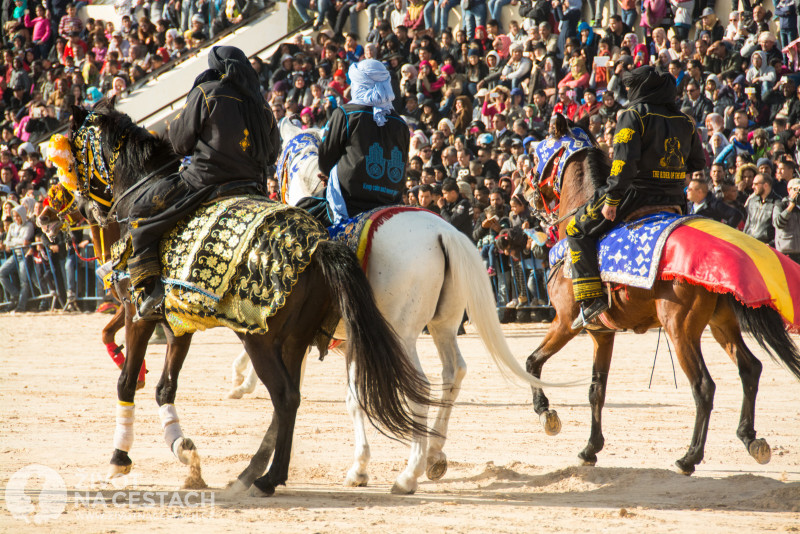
230,120,560,493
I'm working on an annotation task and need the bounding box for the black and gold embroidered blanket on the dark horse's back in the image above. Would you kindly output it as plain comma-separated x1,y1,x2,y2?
126,197,328,335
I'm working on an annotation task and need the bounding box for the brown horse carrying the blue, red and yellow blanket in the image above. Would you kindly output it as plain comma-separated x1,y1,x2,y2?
523,124,800,475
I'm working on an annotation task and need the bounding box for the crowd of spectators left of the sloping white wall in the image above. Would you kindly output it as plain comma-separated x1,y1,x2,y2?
0,0,272,311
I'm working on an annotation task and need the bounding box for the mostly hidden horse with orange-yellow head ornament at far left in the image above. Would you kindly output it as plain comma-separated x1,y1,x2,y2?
36,183,147,389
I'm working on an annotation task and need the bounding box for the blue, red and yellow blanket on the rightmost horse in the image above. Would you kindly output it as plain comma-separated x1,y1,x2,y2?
550,213,800,327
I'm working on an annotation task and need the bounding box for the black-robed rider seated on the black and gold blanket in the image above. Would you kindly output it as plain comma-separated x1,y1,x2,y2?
128,46,281,320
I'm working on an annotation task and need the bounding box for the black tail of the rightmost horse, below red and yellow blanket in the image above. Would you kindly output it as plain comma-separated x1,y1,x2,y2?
728,296,800,379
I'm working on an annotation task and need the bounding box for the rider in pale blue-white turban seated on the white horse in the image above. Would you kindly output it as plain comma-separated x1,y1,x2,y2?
298,59,410,226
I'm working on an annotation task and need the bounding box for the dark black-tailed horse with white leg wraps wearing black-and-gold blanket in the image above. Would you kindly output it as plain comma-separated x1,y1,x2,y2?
62,100,438,495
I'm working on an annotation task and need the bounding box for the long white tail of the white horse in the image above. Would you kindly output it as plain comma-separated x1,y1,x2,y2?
439,225,573,388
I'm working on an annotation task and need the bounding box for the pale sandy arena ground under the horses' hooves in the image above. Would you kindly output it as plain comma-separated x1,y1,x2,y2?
0,314,800,534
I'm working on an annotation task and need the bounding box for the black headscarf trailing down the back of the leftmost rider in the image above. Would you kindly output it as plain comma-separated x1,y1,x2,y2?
194,46,275,170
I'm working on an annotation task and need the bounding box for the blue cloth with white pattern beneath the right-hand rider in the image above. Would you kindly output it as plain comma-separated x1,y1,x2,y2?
550,212,694,289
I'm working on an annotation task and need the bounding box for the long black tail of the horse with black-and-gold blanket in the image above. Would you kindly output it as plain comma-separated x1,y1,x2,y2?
314,241,433,438
